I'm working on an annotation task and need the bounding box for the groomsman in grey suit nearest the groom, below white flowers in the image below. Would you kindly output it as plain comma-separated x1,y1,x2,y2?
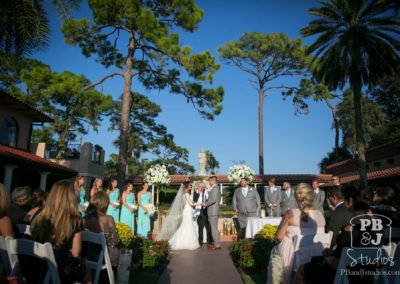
232,178,261,238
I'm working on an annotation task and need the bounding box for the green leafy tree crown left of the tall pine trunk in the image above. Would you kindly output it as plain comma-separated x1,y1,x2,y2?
20,66,115,142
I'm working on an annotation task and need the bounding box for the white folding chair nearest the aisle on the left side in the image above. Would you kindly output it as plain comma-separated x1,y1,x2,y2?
82,231,115,284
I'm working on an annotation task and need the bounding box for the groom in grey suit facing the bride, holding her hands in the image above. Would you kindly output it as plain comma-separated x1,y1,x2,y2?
201,176,221,250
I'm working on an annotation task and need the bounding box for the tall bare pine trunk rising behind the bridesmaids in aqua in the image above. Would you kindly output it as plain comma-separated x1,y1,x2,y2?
117,33,135,189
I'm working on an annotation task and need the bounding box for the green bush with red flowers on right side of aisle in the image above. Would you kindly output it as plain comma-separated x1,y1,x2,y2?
230,239,277,272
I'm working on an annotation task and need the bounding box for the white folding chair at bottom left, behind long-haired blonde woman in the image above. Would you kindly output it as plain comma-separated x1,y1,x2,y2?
6,237,61,284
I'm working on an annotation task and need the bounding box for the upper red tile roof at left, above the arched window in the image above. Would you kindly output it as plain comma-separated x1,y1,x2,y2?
0,90,54,122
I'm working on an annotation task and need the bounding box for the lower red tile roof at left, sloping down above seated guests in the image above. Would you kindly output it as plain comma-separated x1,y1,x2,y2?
0,145,78,174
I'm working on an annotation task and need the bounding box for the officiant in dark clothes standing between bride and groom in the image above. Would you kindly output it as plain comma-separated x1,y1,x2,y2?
193,183,212,246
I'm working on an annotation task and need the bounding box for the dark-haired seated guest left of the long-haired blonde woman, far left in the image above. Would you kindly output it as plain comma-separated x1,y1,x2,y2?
8,186,31,225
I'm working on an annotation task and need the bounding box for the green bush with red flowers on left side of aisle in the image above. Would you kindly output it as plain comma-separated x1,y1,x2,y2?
129,237,170,272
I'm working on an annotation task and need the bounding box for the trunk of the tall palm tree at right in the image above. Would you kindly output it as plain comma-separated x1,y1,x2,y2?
350,77,368,186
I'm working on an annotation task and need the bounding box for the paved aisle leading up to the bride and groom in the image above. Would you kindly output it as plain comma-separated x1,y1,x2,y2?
158,243,243,284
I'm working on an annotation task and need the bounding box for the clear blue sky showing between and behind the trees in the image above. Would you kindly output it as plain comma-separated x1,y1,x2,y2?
34,0,334,174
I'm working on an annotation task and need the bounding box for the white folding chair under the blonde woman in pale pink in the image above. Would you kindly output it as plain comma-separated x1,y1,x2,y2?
293,231,333,271
